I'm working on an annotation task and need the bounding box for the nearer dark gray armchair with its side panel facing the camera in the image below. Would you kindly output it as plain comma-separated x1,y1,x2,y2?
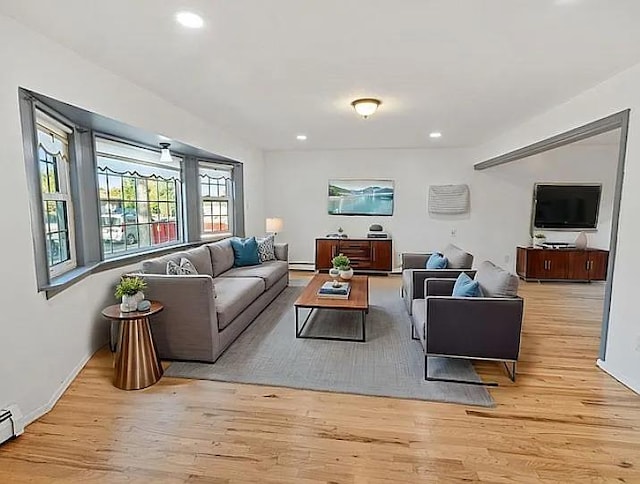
412,262,524,385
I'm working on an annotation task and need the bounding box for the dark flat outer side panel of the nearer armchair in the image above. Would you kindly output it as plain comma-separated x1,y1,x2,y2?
425,296,524,360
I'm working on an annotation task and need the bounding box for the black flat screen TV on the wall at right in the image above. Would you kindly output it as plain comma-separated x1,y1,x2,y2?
533,184,602,230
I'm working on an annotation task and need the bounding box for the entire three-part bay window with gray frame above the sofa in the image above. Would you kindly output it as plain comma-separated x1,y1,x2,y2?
18,88,244,298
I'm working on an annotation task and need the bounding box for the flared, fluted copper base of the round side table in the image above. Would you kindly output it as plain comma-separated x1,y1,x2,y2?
113,318,163,390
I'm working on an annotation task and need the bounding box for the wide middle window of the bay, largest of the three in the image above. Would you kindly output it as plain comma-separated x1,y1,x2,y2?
96,138,183,258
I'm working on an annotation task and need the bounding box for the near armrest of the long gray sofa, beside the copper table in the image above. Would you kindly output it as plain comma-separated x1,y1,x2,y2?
134,274,220,361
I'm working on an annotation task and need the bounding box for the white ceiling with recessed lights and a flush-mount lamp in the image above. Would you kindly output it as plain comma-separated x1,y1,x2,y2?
0,0,640,150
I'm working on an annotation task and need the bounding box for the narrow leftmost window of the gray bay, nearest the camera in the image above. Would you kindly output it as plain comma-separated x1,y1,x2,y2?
36,110,76,277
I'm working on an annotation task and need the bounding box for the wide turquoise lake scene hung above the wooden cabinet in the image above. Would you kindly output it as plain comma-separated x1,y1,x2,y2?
328,179,394,216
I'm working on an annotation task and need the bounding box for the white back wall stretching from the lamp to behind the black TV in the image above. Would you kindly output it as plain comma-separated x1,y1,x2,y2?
265,140,618,270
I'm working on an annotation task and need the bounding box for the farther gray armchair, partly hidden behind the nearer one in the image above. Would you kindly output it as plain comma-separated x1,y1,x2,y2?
402,244,475,314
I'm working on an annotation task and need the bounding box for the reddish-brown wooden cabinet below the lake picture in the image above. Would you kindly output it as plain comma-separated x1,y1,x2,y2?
315,238,393,272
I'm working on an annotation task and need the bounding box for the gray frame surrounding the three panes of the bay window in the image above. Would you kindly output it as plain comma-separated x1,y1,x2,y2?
18,87,244,299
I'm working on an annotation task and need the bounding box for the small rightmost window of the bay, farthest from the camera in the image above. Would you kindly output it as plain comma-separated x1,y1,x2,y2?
198,162,233,236
